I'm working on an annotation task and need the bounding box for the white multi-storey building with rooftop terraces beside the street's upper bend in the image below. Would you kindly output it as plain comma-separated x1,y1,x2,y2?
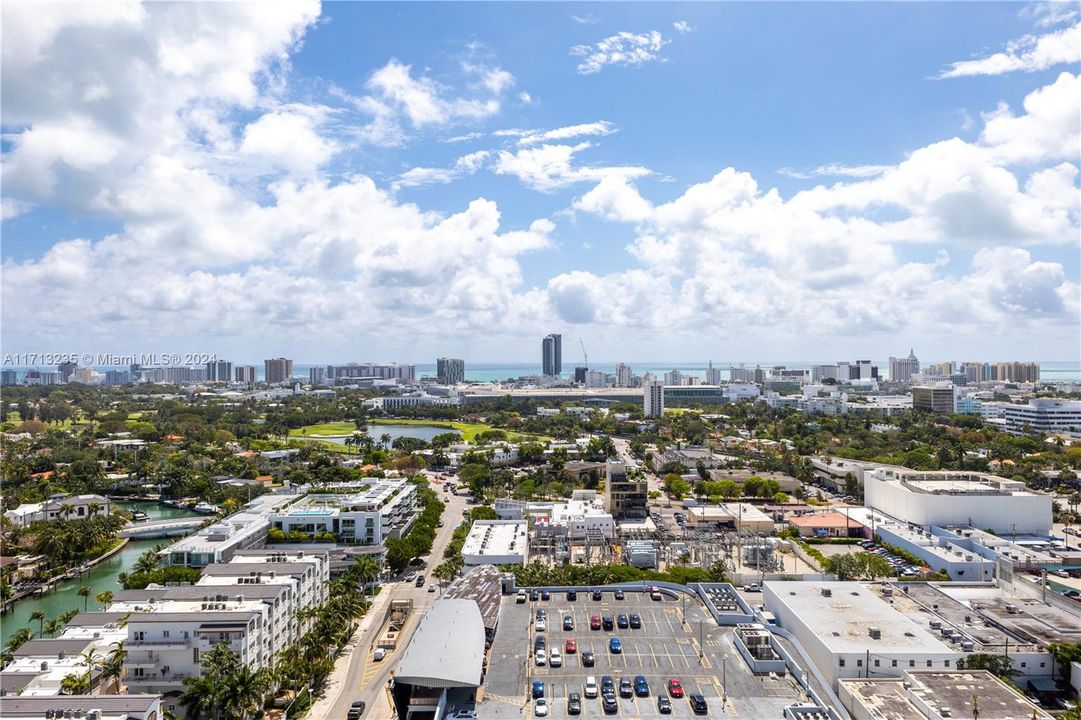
269,479,416,545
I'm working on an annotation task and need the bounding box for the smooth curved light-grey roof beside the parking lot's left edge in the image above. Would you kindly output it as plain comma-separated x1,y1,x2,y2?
395,599,484,688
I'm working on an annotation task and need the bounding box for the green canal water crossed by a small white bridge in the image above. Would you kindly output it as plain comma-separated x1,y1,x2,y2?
0,503,203,648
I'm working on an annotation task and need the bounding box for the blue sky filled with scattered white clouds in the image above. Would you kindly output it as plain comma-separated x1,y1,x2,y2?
0,2,1081,361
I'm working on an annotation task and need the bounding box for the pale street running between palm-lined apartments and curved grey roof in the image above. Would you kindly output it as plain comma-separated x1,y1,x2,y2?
310,483,466,720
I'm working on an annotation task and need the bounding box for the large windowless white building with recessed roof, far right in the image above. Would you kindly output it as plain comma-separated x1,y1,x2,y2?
864,467,1051,536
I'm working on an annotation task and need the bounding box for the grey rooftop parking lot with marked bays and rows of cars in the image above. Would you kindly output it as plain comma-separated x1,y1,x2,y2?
479,590,802,720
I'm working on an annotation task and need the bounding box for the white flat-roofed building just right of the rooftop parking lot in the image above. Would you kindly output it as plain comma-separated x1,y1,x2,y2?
762,581,963,690
